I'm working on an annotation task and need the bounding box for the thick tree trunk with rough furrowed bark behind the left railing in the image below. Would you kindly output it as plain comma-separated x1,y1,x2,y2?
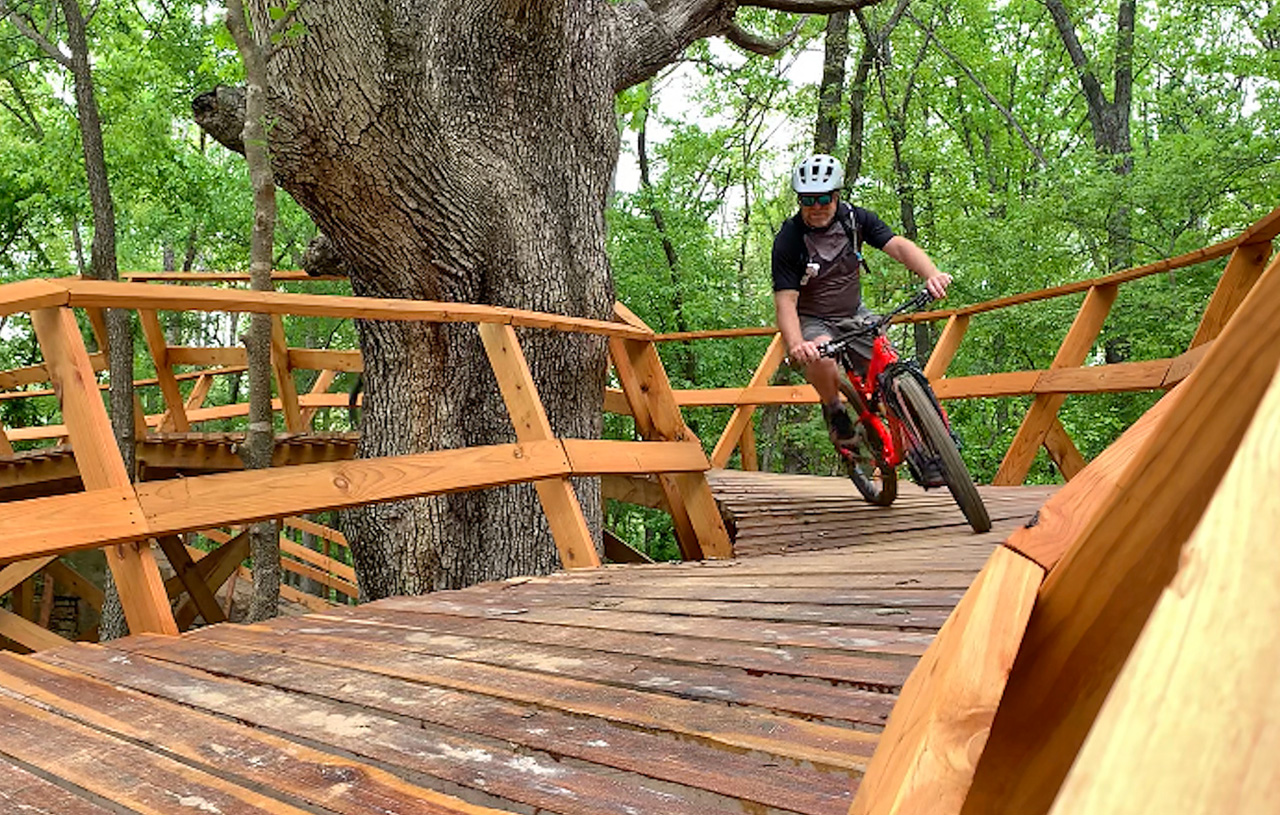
207,0,890,597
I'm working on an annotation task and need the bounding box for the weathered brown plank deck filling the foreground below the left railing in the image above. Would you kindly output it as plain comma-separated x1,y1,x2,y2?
0,475,1043,815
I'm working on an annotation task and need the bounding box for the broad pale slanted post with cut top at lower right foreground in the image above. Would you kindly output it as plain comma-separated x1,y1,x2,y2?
849,546,1044,815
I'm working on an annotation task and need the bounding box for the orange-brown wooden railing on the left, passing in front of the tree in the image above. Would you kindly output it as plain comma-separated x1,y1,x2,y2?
0,280,732,647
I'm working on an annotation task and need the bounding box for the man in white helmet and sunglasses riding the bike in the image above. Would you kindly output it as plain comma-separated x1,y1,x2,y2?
773,154,951,444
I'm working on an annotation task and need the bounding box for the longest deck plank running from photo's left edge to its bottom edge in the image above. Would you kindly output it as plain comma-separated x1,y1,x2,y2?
0,656,512,815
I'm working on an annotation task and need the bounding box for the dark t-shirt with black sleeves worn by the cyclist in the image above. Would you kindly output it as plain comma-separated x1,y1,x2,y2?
773,203,893,317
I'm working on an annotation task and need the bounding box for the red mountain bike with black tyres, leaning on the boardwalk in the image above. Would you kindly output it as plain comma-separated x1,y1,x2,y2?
818,289,991,532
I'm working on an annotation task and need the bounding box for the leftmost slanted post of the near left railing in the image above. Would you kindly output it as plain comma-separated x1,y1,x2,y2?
24,308,178,635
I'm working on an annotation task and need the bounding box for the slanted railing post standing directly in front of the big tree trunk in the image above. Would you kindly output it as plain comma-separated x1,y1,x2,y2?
479,324,600,569
